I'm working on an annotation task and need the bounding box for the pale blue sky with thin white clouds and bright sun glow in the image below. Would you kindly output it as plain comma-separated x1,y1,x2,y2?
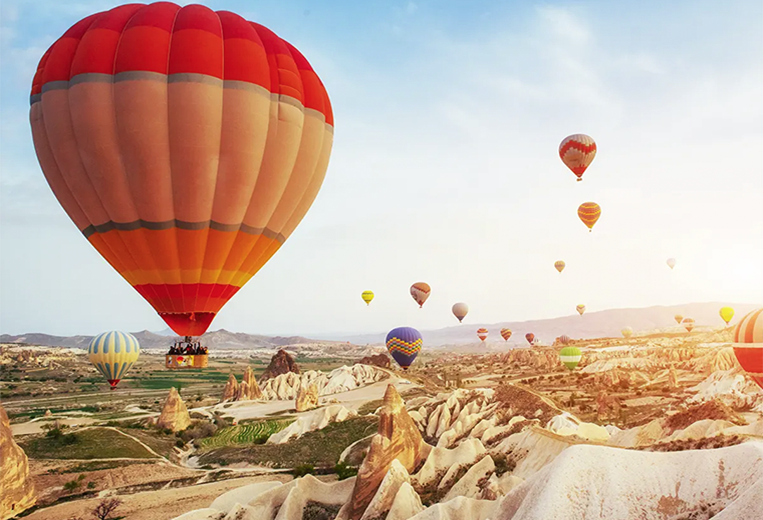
0,0,763,335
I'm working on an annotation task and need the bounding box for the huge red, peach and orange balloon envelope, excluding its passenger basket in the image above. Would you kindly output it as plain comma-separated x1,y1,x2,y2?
30,2,334,342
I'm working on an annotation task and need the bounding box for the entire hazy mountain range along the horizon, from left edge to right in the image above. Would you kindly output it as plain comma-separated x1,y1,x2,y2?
0,302,760,349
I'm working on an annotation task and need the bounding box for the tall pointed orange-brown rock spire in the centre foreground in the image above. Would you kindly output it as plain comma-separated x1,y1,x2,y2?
347,385,431,520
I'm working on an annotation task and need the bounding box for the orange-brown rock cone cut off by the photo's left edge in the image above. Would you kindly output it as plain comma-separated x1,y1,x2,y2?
0,405,36,520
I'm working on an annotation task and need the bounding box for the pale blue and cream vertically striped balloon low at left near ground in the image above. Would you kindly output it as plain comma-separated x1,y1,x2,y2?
87,330,140,390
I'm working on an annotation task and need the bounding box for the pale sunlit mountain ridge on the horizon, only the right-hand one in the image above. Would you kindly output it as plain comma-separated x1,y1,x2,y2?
326,302,761,347
